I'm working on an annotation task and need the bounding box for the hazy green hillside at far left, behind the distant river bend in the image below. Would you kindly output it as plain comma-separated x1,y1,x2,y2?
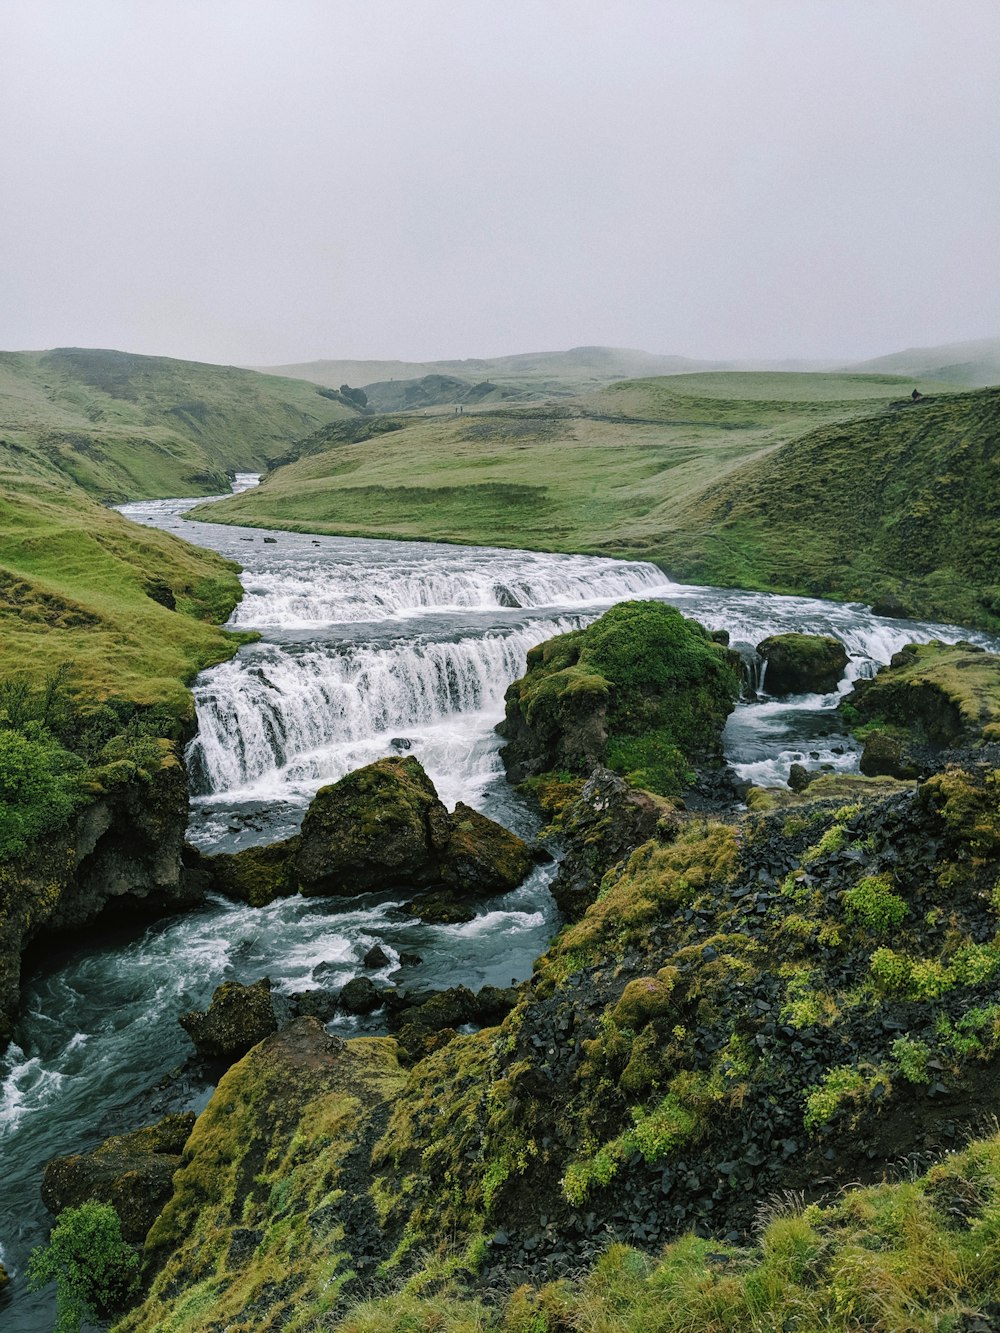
0,348,355,500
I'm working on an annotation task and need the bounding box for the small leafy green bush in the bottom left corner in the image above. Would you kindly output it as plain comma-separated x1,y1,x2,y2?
28,1204,139,1333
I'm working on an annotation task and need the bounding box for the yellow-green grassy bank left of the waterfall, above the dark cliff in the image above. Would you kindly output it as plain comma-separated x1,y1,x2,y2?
0,479,249,720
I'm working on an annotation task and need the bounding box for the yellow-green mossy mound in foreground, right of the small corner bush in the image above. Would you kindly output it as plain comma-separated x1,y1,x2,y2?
117,1018,403,1333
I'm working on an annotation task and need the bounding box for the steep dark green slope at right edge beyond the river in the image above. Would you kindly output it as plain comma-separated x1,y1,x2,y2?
663,389,1000,628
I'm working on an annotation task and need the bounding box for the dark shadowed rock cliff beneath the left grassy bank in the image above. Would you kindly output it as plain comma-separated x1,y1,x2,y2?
0,742,204,1050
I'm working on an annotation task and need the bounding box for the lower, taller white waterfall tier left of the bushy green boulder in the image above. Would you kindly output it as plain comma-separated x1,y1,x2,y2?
188,616,583,796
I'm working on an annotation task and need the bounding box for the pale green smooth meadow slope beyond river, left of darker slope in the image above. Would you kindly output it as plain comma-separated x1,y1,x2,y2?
188,373,911,559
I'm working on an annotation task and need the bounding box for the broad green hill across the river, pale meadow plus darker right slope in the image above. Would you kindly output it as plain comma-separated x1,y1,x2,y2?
192,372,981,623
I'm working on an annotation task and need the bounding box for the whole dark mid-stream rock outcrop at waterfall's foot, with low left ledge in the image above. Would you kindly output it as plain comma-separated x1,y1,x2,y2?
199,756,531,920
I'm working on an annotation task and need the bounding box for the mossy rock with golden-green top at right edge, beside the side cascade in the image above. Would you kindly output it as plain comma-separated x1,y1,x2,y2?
841,640,1000,777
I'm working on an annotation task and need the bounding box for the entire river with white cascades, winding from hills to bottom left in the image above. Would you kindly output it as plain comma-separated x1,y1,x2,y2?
0,475,1000,1333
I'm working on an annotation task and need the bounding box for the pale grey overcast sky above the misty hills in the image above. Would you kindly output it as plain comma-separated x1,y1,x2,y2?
0,0,1000,364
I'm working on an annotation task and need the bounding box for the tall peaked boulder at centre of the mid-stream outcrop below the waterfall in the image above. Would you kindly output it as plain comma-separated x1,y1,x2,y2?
295,756,451,894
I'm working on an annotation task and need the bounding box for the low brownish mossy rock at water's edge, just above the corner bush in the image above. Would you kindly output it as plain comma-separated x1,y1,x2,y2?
41,1112,195,1244
